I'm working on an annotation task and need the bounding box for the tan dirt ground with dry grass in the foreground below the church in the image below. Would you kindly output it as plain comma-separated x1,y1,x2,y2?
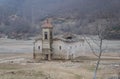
0,54,120,79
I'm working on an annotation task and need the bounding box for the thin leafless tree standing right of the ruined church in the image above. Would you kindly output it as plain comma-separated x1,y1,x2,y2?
83,19,108,79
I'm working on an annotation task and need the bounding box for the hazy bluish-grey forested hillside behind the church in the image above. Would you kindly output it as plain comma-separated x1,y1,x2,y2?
0,0,120,39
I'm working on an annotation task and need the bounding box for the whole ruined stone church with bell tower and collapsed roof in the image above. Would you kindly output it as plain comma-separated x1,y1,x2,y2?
33,19,84,60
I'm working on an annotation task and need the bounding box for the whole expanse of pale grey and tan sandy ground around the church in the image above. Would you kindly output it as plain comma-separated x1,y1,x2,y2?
0,39,120,79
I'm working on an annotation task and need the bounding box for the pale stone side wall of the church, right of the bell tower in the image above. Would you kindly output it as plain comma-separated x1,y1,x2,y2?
53,40,85,59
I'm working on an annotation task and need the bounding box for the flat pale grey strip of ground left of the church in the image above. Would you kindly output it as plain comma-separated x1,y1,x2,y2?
0,38,34,54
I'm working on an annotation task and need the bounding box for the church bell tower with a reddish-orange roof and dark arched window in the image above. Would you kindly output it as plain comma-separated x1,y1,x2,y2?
42,19,53,60
